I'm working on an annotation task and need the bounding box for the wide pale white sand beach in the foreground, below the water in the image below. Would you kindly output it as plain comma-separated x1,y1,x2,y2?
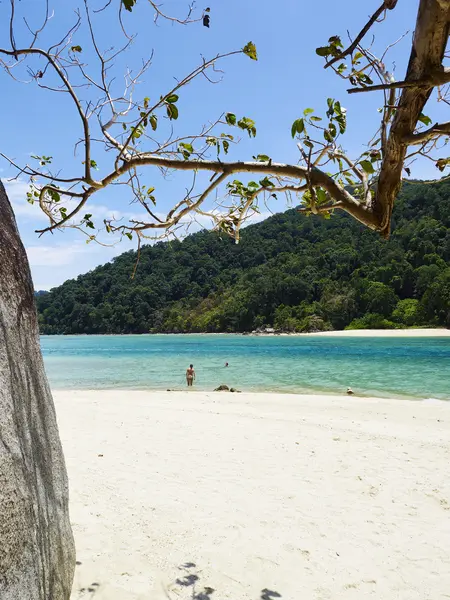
54,391,450,600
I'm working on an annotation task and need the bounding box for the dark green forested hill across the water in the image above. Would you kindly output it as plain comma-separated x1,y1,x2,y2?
36,182,450,333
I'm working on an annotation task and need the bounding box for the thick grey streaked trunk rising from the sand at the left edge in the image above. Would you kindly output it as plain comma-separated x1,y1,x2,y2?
0,182,75,600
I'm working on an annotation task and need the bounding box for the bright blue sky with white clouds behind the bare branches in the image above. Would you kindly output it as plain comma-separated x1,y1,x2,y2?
0,0,442,289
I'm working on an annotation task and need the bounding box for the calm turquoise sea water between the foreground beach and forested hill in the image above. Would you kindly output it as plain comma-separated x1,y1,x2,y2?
41,335,450,400
